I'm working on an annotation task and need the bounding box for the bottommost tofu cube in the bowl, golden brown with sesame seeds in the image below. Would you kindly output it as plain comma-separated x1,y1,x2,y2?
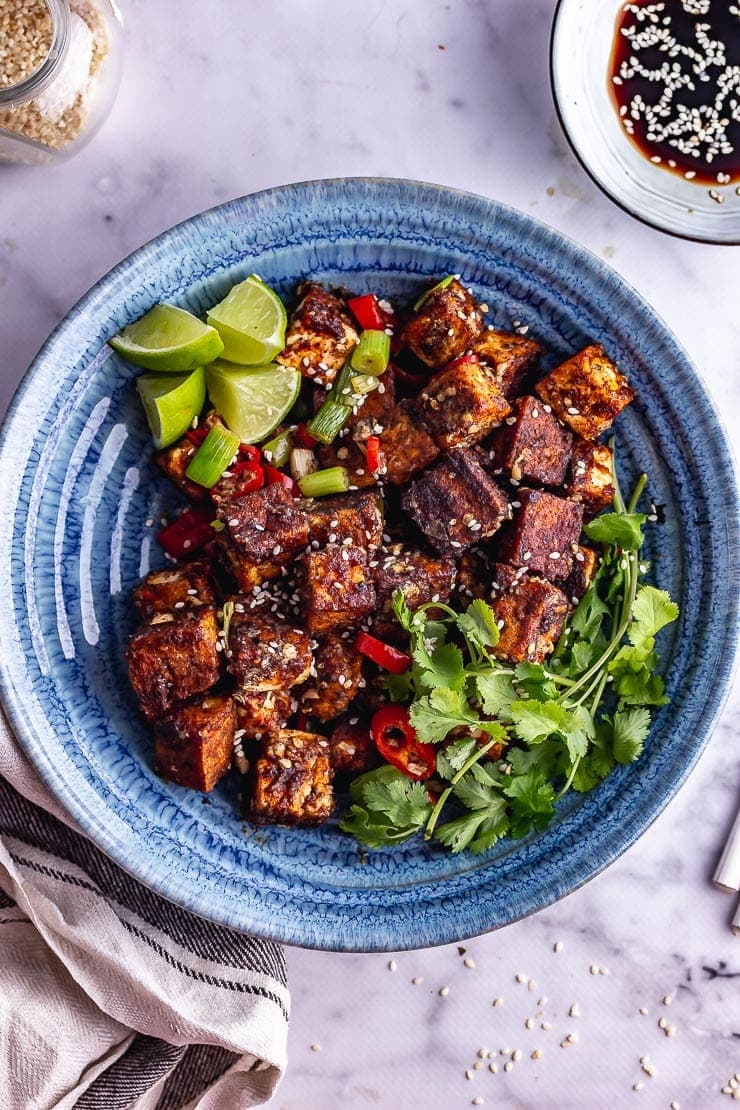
246,728,334,825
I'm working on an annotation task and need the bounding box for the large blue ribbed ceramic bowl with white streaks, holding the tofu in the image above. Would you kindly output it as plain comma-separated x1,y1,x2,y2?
0,180,738,951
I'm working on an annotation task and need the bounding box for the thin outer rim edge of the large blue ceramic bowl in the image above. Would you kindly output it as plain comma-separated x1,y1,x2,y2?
0,176,740,952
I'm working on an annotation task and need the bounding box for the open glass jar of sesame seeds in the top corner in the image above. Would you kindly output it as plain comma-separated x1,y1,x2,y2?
0,0,122,163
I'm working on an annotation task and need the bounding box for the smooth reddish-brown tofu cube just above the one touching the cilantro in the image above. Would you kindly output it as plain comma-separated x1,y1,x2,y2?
499,490,584,582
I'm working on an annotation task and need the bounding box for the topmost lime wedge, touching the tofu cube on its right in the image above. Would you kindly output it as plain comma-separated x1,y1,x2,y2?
209,274,287,366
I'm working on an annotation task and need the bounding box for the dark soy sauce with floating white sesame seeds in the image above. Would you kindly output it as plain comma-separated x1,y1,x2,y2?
609,0,740,185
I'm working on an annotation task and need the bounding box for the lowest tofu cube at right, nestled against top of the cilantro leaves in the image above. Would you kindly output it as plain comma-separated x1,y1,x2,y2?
490,571,570,663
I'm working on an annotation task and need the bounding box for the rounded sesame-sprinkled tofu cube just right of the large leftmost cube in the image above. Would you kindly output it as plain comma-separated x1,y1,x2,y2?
227,598,313,692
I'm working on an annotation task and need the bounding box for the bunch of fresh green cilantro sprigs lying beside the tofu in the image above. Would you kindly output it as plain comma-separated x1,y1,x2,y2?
342,450,679,852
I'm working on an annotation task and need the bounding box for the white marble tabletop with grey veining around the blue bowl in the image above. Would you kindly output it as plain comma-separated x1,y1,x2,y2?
0,0,740,1110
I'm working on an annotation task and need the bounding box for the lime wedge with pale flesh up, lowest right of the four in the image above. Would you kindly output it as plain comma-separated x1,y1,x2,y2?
205,360,301,443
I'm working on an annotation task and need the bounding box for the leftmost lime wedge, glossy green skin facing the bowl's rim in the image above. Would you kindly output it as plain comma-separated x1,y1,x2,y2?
110,304,223,374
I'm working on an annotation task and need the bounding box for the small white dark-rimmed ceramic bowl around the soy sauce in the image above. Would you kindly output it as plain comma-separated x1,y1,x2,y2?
550,0,740,243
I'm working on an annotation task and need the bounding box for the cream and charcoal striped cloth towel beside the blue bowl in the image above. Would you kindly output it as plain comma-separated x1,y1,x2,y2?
0,712,290,1110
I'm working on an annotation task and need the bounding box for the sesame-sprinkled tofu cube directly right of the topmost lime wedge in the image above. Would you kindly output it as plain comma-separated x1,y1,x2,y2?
275,283,358,382
